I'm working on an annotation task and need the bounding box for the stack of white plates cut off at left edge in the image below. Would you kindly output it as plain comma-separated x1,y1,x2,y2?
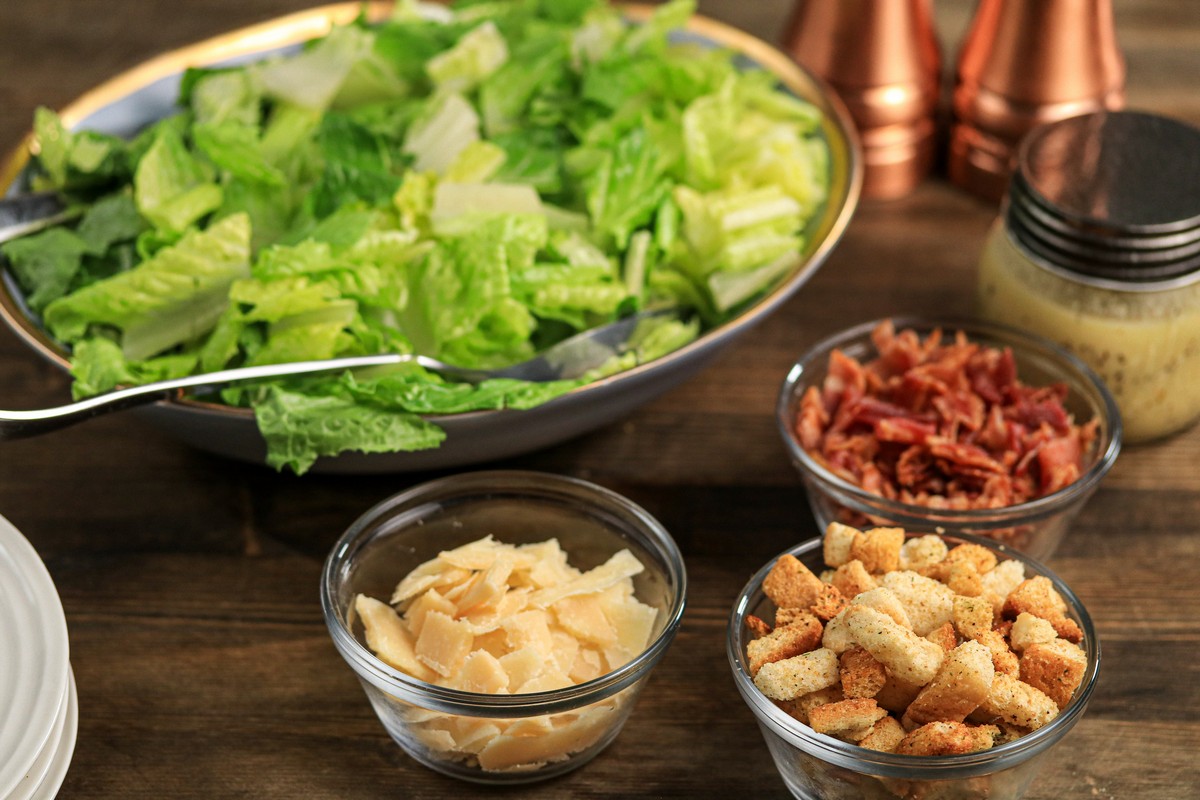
0,517,79,800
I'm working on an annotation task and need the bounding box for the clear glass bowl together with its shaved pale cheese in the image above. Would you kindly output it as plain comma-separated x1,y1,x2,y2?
320,471,688,784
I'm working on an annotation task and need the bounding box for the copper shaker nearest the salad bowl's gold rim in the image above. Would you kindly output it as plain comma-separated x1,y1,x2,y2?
784,0,942,198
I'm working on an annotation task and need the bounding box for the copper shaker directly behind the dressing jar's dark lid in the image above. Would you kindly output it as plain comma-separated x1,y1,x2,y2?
948,0,1124,201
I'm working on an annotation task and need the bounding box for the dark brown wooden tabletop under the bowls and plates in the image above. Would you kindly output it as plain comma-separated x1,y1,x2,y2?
0,0,1200,800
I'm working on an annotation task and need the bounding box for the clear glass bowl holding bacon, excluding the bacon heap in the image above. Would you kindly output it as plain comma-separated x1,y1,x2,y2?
775,318,1122,559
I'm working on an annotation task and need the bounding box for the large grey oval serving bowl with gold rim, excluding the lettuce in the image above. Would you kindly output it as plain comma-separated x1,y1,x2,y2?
0,2,862,473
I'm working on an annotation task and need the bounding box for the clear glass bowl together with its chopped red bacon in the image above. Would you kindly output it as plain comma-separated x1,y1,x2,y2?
776,318,1121,559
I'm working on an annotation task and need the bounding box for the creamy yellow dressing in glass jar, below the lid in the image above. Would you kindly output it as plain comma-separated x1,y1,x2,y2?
976,221,1200,441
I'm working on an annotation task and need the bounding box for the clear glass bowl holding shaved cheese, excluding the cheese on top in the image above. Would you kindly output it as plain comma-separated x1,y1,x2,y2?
320,471,688,784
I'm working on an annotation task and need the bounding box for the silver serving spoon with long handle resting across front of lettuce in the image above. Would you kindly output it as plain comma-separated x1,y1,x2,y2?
0,311,668,441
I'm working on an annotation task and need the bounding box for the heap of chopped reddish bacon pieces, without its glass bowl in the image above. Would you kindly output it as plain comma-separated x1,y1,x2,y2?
796,321,1099,537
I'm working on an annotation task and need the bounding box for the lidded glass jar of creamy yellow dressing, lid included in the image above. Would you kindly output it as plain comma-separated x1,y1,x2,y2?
976,112,1200,443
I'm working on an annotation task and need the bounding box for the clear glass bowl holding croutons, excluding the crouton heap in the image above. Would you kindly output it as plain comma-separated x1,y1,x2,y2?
726,533,1100,800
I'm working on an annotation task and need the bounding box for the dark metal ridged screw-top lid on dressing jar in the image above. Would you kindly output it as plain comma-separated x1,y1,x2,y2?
1006,112,1200,283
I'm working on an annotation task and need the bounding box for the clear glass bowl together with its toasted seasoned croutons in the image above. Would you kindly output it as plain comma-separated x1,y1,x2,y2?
727,523,1100,800
